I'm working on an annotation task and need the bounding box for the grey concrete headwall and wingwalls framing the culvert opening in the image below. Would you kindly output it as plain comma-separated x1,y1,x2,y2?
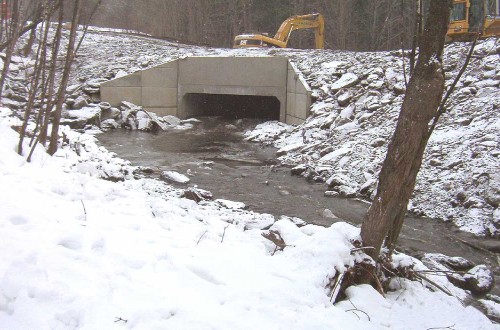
101,56,311,124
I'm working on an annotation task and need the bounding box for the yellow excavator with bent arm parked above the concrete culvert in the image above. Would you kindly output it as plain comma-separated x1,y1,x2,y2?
233,14,325,49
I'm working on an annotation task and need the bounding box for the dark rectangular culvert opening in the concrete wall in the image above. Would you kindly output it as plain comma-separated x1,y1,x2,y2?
183,93,280,120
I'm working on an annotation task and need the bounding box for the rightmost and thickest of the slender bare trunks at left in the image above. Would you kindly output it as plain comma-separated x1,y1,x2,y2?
48,0,80,155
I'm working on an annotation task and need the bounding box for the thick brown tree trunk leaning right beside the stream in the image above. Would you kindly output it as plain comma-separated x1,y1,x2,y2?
361,0,452,259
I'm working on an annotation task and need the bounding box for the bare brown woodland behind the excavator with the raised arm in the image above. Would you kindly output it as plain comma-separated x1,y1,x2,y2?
90,0,418,51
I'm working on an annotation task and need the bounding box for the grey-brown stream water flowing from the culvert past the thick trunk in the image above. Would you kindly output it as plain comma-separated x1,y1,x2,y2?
97,117,499,294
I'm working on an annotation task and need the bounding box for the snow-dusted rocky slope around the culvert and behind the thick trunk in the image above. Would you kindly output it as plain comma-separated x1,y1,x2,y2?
68,29,500,237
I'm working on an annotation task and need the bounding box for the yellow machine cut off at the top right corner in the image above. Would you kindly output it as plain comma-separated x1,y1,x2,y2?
447,0,500,41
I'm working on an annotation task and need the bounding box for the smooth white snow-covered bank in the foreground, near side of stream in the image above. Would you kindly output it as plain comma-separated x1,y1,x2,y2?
0,111,496,329
